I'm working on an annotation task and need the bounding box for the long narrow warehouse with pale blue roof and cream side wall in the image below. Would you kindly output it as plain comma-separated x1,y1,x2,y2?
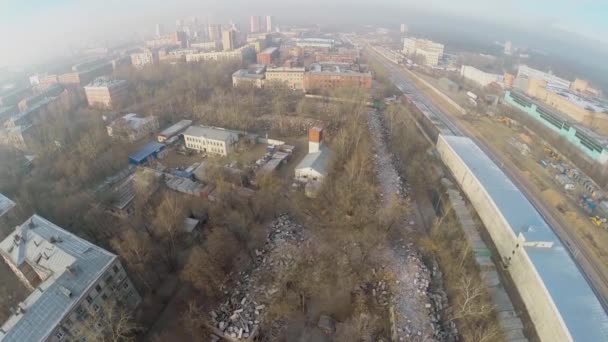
437,135,608,341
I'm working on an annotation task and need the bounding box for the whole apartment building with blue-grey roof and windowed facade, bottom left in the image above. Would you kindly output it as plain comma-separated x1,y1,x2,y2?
0,215,141,342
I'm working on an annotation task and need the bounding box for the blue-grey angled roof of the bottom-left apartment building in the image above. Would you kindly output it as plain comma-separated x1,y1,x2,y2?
0,215,117,342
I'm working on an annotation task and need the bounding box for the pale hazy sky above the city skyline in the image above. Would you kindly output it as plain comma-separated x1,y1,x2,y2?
0,0,608,66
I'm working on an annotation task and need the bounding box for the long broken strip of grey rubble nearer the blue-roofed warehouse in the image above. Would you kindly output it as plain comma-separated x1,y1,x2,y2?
368,111,456,341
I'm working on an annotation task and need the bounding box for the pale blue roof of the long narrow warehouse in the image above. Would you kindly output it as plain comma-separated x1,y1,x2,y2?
441,135,608,341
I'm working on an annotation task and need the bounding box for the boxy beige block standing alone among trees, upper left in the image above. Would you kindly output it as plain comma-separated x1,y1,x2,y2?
84,77,128,108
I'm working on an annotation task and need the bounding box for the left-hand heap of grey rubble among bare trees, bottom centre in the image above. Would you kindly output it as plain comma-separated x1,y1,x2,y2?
209,215,304,340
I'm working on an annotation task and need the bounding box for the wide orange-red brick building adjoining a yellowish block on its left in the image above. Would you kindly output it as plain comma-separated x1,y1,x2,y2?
304,63,372,91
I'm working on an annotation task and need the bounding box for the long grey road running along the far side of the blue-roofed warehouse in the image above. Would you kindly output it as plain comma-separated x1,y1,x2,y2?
366,48,608,311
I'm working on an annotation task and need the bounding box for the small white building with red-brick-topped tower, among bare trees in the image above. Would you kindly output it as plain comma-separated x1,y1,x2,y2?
295,127,330,183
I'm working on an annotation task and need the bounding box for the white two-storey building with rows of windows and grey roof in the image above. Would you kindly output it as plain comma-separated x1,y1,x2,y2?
184,126,239,156
